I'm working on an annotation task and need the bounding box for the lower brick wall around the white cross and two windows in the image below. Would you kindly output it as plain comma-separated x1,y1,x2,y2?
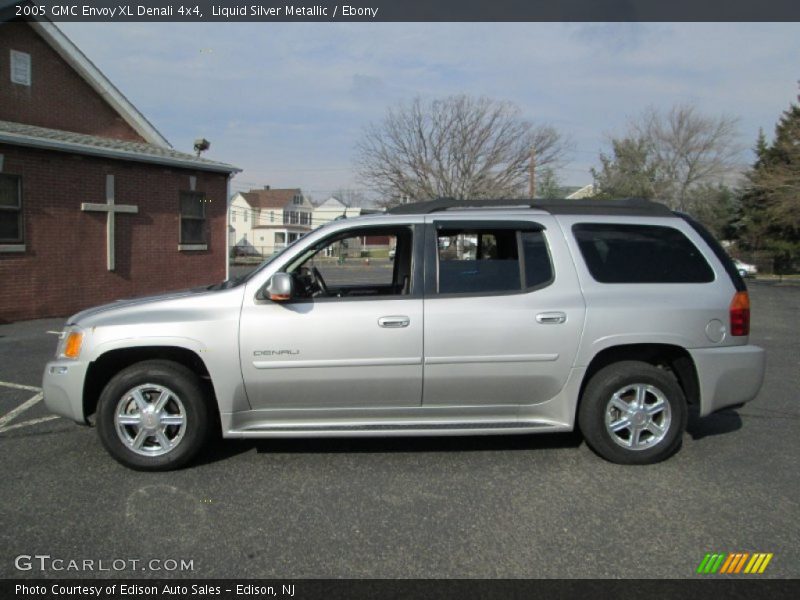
0,144,227,322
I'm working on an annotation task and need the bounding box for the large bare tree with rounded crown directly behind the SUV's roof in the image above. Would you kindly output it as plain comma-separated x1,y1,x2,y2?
356,95,565,204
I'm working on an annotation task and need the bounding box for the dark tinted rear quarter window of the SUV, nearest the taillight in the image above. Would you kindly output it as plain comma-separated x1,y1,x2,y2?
572,223,714,283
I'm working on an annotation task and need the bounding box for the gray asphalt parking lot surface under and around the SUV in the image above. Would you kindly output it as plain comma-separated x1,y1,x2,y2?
0,282,800,578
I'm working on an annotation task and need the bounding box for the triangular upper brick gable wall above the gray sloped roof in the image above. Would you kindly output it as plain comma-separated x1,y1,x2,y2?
0,22,144,141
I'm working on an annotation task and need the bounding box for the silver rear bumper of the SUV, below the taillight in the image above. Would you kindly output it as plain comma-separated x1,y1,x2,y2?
689,345,766,416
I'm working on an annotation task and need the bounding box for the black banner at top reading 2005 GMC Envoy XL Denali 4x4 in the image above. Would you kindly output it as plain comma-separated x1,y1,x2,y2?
0,0,800,22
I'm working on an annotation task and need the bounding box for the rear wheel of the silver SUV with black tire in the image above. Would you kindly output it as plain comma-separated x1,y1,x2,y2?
578,361,688,465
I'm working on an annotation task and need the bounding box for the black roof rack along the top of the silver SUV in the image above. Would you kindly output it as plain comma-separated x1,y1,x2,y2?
386,198,673,217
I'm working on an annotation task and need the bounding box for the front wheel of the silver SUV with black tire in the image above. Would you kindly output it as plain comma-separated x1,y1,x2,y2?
96,360,212,471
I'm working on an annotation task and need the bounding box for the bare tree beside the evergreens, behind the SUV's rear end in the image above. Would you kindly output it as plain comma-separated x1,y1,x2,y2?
593,104,742,210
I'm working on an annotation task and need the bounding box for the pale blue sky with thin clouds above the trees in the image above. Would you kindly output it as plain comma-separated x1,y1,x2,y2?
59,23,800,201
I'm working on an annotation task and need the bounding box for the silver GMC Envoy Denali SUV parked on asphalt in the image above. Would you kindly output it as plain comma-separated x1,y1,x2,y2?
43,200,764,470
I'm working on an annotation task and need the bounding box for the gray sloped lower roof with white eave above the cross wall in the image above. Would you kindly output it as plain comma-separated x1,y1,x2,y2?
0,121,241,173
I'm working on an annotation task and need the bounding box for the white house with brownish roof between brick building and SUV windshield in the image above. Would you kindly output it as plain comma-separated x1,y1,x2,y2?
228,186,316,256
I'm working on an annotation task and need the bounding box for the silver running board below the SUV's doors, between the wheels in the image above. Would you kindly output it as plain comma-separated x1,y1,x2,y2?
225,421,571,438
